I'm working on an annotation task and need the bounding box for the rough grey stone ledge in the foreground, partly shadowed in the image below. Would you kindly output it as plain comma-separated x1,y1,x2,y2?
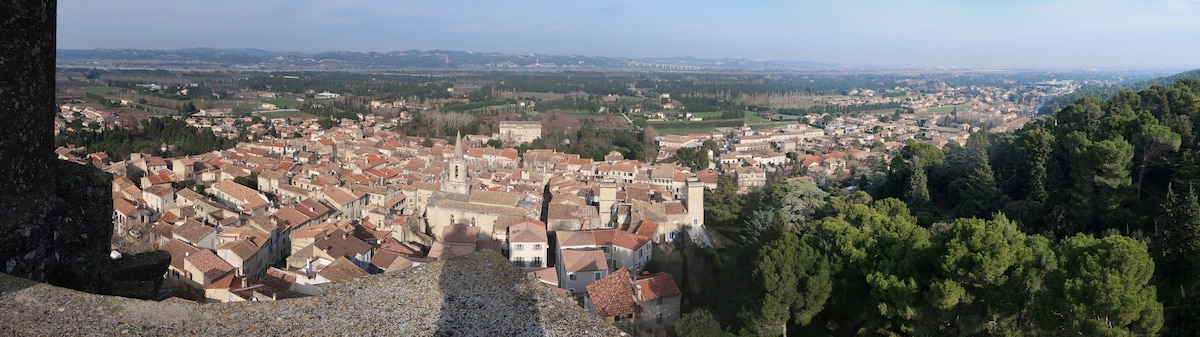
0,251,623,336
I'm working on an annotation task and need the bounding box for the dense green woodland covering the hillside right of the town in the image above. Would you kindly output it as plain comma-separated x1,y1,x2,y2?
679,79,1200,336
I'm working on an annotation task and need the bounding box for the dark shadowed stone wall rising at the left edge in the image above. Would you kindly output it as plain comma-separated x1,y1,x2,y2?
0,0,131,293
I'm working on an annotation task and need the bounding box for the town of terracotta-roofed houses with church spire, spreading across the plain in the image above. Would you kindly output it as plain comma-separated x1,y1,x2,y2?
55,64,1123,331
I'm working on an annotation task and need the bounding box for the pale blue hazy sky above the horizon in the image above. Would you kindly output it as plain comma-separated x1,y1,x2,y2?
58,0,1200,68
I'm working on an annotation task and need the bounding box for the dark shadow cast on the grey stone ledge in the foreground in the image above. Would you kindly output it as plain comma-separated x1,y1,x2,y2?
433,252,545,336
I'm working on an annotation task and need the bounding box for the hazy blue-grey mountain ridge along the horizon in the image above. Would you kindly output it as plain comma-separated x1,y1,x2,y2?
58,48,840,71
